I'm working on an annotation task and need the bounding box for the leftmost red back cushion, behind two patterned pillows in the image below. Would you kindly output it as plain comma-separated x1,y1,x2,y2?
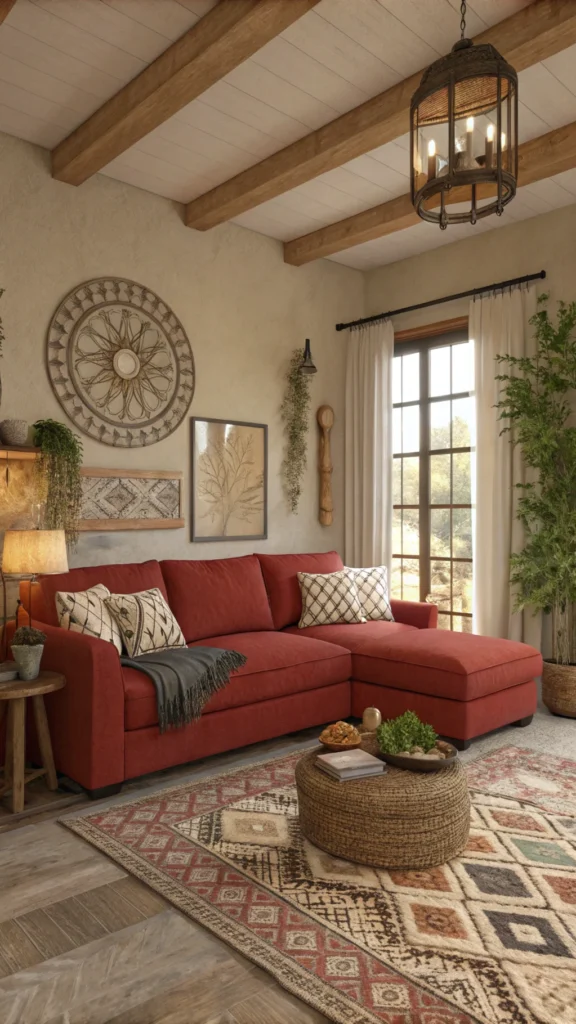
33,561,167,626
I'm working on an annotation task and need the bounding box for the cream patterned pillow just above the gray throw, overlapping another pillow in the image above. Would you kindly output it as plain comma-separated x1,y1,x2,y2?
106,587,186,657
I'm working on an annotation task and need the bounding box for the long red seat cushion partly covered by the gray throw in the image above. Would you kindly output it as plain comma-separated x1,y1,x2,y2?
122,632,351,731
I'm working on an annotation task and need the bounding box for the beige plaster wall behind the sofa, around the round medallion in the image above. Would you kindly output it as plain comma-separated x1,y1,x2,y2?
0,135,364,564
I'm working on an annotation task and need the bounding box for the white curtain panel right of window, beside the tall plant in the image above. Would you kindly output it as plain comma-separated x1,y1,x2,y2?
469,286,541,647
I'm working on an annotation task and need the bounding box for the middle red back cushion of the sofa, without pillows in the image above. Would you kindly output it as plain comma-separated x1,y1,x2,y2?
161,555,274,643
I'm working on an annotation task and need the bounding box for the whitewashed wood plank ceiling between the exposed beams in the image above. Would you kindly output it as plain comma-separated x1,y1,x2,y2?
0,0,576,269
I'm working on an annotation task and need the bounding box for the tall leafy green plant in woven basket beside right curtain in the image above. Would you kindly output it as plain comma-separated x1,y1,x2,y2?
497,295,576,718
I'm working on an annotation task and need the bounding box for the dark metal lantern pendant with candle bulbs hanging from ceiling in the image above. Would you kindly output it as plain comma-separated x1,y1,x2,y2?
410,2,518,228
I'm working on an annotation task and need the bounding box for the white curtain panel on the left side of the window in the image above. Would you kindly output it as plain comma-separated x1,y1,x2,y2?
344,319,394,572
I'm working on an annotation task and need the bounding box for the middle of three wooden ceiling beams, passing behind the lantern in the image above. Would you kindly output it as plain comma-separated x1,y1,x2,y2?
186,0,576,230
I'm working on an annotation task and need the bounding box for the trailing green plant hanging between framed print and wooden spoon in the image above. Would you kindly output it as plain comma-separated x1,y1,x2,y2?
281,348,311,513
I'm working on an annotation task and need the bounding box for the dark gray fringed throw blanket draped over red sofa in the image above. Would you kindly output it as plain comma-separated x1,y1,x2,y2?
120,647,246,732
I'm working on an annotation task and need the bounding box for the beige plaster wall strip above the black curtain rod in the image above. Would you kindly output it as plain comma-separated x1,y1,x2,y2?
366,205,576,330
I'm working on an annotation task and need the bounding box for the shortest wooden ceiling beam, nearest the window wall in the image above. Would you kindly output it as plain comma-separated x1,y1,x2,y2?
284,121,576,266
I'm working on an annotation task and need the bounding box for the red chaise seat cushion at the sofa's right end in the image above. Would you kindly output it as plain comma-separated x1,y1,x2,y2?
353,630,542,700
